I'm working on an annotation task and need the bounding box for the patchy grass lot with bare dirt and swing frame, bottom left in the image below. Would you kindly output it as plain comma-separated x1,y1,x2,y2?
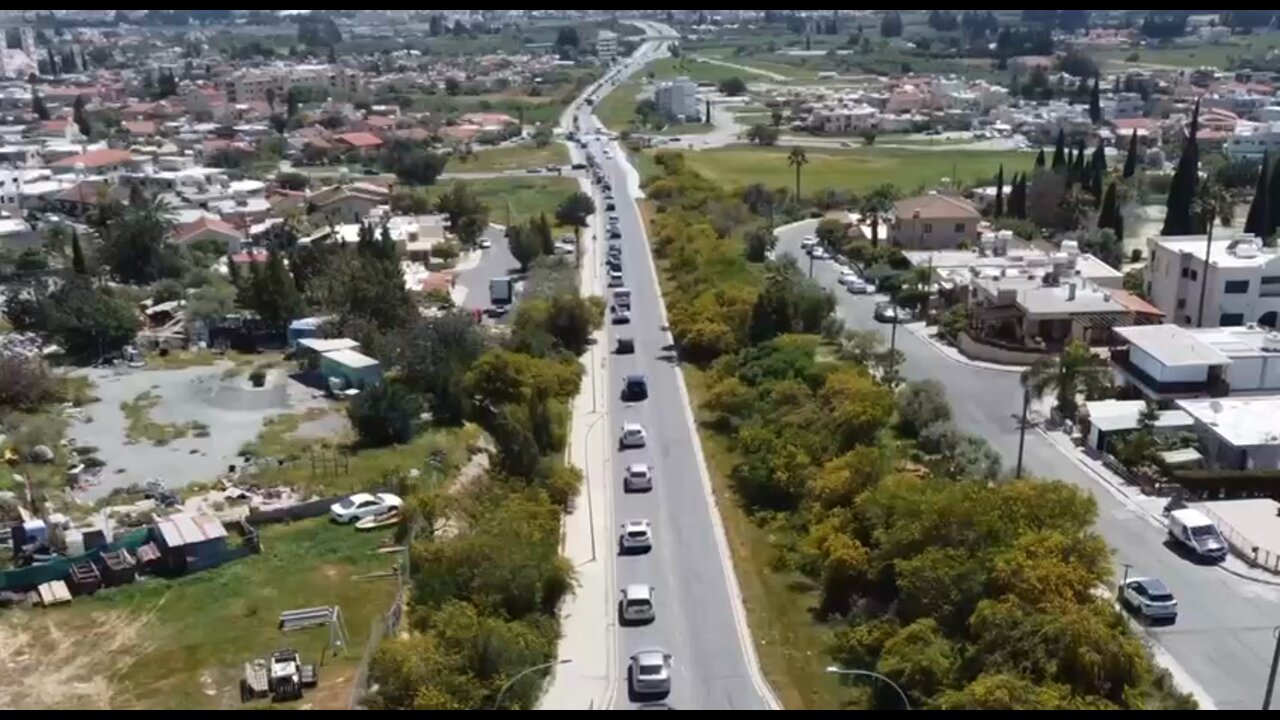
0,518,397,710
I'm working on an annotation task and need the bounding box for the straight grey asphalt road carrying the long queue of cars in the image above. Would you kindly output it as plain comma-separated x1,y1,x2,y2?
580,29,768,710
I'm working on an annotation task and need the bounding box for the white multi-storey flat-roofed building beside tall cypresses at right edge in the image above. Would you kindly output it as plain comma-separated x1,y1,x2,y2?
1147,231,1280,328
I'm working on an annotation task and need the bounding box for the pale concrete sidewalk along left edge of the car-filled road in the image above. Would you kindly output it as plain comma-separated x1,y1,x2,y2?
538,137,617,710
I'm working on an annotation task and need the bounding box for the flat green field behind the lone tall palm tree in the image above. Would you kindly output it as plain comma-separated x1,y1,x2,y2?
665,145,1036,193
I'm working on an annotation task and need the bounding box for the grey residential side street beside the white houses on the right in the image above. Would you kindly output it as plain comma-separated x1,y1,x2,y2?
776,223,1280,710
